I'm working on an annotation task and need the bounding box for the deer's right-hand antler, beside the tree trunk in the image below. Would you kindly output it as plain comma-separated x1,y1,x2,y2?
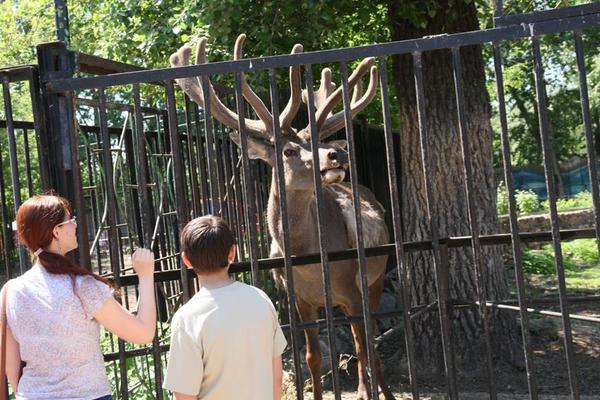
299,57,378,140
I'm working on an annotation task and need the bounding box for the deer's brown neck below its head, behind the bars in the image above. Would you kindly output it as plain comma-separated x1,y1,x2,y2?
268,172,316,250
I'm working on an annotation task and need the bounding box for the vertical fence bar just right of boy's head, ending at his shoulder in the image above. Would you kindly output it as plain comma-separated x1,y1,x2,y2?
232,73,258,286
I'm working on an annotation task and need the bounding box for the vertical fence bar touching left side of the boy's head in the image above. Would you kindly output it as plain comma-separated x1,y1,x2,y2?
165,81,190,302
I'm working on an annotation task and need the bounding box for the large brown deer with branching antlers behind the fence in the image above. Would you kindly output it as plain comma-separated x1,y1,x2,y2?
170,34,394,400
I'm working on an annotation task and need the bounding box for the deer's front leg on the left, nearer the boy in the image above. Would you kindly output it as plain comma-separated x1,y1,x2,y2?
296,299,323,400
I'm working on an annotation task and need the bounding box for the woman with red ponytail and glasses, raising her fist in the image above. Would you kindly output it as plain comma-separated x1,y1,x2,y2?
2,195,156,400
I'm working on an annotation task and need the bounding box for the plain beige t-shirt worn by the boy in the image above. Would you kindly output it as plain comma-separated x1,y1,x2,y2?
163,282,287,400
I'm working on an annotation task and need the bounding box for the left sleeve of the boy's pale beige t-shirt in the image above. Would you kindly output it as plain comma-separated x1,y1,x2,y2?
163,316,204,396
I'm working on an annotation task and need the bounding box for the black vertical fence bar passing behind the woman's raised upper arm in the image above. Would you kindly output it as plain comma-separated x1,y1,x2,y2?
99,88,129,400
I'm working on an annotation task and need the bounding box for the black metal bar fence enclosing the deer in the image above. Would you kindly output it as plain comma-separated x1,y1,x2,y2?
0,4,600,399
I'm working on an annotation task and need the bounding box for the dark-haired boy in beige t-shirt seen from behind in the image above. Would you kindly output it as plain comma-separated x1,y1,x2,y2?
163,215,286,400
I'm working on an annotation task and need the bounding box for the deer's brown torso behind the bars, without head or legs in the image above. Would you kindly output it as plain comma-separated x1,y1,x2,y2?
268,182,389,307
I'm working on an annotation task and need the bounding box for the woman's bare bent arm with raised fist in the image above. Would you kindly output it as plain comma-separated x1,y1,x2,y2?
94,249,156,344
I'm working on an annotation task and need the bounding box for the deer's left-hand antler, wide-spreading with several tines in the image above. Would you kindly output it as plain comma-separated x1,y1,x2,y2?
170,34,303,139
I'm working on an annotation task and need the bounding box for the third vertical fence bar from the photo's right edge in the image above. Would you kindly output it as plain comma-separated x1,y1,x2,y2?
493,42,538,400
